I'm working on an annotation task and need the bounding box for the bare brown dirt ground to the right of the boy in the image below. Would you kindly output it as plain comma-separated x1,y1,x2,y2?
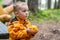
31,22,60,40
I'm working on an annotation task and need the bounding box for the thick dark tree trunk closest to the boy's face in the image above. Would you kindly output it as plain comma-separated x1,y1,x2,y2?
28,0,38,12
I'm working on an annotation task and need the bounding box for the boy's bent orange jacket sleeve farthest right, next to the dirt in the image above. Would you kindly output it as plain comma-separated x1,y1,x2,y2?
27,23,38,38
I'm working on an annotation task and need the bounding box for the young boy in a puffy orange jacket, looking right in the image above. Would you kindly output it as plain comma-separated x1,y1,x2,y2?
8,2,38,40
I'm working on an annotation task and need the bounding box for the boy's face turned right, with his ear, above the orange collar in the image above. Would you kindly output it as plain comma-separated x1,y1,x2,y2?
15,4,29,19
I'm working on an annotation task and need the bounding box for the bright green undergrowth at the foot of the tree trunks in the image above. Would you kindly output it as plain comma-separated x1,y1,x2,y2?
28,9,60,22
